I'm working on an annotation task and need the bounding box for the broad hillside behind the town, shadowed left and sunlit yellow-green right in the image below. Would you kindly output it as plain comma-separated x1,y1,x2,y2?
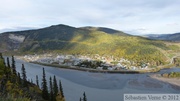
0,25,180,65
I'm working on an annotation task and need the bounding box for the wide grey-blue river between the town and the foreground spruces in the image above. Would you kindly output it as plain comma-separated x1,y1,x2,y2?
12,59,180,101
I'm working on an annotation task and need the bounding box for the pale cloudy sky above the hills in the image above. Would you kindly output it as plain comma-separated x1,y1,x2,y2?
0,0,180,35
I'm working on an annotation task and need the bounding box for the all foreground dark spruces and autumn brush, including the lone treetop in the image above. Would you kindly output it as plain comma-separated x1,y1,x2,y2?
0,53,87,101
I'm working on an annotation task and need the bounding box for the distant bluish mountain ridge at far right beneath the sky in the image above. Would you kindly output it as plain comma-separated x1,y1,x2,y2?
145,33,180,42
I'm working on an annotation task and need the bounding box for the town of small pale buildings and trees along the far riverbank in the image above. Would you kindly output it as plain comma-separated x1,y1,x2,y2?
18,54,150,71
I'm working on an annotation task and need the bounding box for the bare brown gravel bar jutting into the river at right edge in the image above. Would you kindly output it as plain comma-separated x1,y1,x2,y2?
150,74,180,87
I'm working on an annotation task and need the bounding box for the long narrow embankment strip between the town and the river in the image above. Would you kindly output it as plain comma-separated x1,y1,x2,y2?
16,56,175,74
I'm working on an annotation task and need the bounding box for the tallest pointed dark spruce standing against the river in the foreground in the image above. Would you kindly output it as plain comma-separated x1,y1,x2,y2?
42,68,49,100
